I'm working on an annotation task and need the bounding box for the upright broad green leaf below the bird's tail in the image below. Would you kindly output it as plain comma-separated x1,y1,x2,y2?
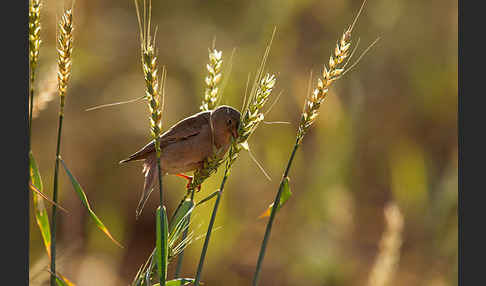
155,206,169,281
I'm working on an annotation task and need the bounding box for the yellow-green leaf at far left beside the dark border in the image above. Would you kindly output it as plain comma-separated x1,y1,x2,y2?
29,152,51,257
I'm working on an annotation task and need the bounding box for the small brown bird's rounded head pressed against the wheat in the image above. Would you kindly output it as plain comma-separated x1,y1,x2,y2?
211,105,241,139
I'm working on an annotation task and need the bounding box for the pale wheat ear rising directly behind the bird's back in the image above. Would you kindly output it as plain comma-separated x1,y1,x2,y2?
199,48,223,111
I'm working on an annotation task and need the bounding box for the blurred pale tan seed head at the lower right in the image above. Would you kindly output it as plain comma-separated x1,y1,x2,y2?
368,202,403,286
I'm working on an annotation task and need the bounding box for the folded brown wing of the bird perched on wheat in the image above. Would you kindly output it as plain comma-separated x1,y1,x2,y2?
120,111,210,163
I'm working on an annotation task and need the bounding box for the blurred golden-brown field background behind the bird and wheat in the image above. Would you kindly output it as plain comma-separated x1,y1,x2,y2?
29,0,458,286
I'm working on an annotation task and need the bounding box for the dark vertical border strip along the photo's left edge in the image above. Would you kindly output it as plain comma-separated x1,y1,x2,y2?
4,0,30,285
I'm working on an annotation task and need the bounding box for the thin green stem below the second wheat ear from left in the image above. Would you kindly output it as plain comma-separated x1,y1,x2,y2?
51,95,65,286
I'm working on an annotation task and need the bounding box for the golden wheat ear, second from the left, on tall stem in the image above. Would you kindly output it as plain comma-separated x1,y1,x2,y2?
57,9,73,97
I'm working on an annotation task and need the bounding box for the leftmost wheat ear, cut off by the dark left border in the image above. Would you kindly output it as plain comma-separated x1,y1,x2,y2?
29,0,42,83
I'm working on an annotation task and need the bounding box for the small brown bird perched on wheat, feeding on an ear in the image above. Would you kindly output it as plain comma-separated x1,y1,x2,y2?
120,105,240,218
